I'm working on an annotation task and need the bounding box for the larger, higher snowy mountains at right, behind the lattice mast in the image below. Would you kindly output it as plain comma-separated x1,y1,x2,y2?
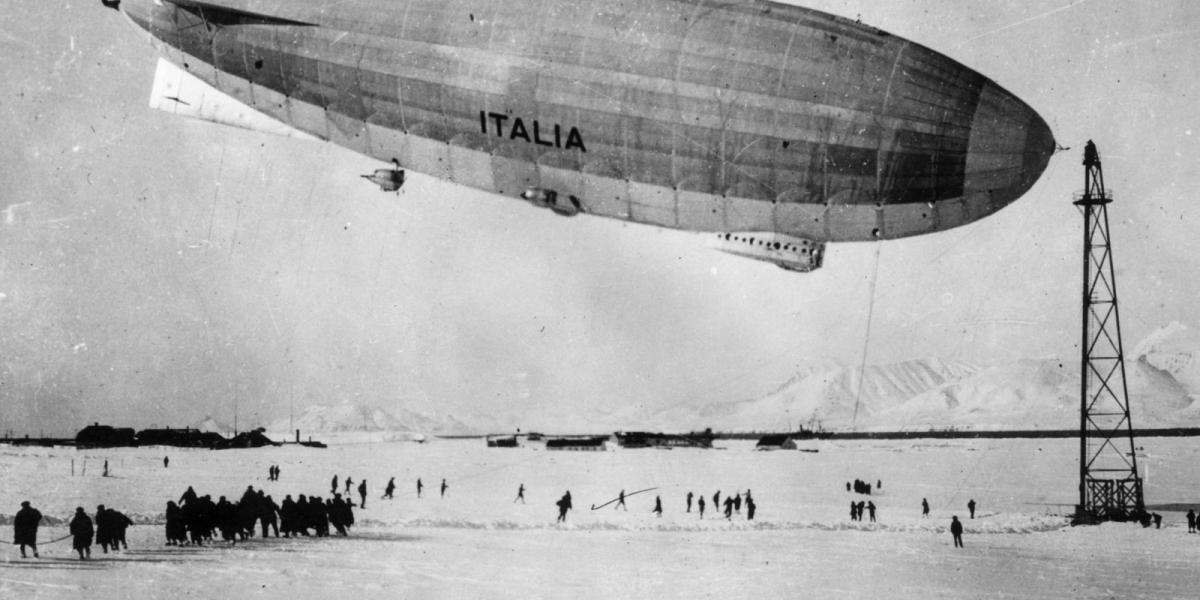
652,323,1200,431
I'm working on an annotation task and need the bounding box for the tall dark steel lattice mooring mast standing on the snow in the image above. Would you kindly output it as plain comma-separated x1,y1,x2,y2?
1075,140,1146,523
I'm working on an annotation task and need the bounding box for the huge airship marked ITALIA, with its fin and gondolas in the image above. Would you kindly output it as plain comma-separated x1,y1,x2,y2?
102,0,1056,272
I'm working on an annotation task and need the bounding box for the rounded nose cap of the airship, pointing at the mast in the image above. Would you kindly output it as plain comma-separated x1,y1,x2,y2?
964,82,1055,212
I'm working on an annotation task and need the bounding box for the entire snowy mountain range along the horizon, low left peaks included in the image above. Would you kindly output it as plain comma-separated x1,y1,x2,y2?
231,323,1200,436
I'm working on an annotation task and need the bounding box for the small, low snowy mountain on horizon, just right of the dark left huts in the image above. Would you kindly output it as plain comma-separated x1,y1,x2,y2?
268,403,476,434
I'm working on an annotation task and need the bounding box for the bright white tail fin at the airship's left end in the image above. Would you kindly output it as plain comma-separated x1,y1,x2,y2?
150,58,319,139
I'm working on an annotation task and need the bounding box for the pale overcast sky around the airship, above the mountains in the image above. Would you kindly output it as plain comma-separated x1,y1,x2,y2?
0,0,1200,434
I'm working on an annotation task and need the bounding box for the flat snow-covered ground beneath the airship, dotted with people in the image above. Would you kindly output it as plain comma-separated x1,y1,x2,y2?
0,438,1200,599
